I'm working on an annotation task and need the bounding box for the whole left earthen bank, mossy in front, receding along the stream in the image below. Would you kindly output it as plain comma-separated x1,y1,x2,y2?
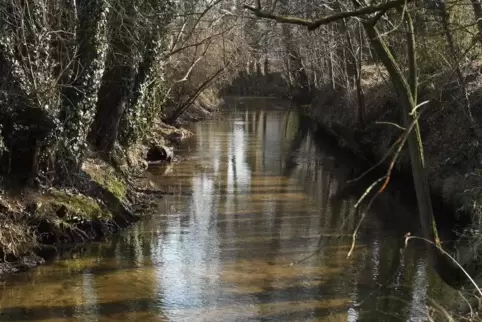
0,103,214,275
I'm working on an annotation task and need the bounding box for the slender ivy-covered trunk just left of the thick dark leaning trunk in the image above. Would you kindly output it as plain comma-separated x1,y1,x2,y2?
58,0,108,175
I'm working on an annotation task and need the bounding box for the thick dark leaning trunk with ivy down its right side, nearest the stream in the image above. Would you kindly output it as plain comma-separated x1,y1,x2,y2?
89,0,174,153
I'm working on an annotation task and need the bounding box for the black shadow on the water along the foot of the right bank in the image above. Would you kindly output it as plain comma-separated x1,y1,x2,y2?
286,115,468,288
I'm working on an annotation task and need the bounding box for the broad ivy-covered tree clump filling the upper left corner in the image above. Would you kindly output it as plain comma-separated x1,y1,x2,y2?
0,0,107,180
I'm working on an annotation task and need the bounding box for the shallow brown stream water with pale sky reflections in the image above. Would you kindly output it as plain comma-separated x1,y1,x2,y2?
0,103,456,321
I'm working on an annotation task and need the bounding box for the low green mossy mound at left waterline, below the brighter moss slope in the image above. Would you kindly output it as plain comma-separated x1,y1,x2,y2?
37,190,112,221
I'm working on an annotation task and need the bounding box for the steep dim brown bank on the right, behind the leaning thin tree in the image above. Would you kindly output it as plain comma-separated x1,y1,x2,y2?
304,66,482,228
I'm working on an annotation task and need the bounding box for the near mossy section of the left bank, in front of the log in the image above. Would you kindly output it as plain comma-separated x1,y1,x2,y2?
0,158,139,273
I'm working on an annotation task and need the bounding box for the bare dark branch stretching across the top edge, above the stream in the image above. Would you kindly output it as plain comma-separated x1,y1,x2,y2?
244,0,411,30
